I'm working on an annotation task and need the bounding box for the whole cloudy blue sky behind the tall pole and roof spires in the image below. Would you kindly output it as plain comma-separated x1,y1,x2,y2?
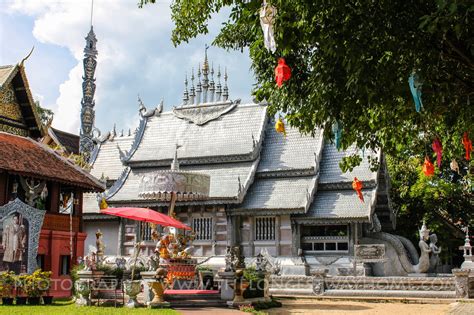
0,0,254,133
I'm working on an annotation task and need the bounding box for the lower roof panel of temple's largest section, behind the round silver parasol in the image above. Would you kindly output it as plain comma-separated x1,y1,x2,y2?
108,159,259,204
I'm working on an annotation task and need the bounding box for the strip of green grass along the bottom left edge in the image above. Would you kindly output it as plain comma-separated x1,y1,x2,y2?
0,300,179,315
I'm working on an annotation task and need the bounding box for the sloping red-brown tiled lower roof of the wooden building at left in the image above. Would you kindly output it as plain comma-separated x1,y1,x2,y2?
0,132,104,191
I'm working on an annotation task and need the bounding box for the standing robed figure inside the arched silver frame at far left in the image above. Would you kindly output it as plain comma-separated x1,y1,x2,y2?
2,213,26,273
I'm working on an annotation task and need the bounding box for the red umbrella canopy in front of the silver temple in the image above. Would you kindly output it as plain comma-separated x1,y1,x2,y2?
100,207,191,230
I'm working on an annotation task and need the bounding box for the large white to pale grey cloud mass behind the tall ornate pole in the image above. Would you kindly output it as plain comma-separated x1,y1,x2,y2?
4,0,253,133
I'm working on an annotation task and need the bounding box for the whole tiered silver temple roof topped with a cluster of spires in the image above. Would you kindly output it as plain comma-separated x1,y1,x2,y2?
85,54,384,225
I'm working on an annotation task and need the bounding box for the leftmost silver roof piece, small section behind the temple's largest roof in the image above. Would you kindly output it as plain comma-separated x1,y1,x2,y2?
91,136,134,180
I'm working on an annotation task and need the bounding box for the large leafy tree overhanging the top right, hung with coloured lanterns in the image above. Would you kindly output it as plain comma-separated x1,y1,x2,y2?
139,0,474,170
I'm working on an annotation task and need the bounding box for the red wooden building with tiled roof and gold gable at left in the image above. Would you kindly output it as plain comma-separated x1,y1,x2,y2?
0,64,104,296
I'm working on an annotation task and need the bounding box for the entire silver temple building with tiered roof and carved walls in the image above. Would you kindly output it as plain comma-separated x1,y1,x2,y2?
84,52,395,274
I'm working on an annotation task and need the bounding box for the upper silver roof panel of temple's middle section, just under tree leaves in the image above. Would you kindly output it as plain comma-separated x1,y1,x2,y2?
257,122,323,173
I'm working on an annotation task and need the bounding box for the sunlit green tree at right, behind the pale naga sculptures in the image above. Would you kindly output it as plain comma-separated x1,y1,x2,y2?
387,157,474,265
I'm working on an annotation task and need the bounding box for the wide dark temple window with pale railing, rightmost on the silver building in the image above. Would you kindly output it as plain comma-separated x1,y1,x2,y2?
301,225,349,254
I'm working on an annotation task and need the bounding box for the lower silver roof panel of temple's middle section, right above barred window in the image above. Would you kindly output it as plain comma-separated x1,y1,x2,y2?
233,176,317,214
